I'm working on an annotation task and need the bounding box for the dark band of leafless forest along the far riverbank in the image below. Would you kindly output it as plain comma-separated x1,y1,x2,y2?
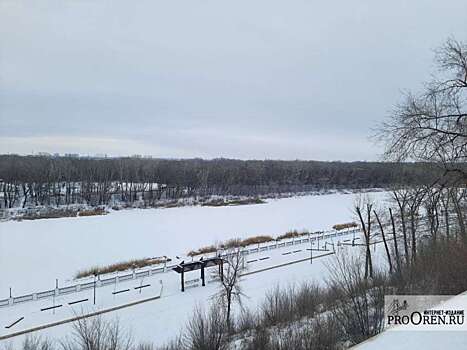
0,155,433,208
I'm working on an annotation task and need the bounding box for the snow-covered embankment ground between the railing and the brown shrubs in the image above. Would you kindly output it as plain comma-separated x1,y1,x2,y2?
0,227,388,344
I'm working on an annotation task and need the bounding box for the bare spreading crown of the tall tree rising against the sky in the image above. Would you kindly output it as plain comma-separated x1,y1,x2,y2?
378,39,467,184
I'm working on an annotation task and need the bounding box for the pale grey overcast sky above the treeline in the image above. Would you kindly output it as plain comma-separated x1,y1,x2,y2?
0,0,467,160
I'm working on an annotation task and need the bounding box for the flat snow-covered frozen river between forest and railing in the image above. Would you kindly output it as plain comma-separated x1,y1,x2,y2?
0,192,384,298
